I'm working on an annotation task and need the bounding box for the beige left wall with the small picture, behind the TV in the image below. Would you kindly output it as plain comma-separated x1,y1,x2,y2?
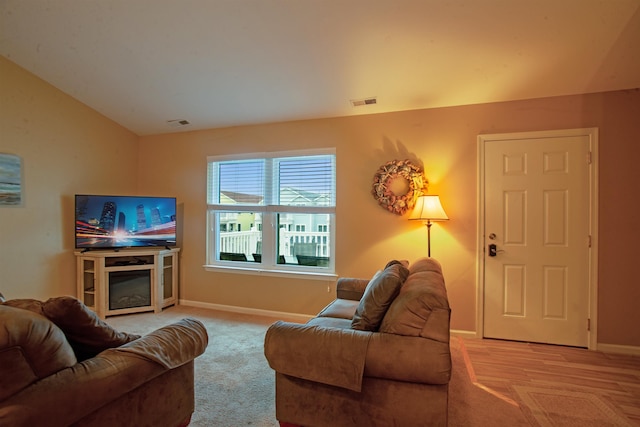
0,56,138,299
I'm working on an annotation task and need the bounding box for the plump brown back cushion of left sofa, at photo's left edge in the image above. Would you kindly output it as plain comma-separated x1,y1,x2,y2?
0,304,77,401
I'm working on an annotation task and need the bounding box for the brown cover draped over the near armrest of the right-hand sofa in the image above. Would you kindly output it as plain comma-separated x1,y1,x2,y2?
264,321,371,391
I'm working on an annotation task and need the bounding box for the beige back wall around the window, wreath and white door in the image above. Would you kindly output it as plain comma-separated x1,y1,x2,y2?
139,91,640,345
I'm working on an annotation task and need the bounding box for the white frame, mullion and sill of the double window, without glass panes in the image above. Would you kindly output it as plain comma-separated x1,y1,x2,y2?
204,148,337,281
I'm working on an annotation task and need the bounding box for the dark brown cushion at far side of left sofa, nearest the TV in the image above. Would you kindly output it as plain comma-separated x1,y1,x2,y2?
4,296,140,361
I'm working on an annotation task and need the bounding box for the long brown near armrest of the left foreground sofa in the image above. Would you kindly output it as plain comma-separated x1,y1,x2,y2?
0,320,206,427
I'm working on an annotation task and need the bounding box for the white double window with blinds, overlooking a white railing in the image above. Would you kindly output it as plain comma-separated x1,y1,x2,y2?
207,150,336,275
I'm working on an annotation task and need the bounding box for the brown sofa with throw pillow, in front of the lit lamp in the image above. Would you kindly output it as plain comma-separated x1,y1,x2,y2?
265,258,451,427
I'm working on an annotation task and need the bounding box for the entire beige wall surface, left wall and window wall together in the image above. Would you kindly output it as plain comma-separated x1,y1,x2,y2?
0,54,640,346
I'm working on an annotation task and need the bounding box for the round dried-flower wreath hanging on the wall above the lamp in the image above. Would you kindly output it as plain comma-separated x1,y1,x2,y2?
371,160,428,215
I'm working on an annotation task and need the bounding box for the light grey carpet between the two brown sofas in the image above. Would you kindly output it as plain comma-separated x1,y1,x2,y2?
107,306,278,427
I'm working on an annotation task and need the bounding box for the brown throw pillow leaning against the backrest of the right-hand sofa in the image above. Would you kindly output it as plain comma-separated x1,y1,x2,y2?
351,260,409,331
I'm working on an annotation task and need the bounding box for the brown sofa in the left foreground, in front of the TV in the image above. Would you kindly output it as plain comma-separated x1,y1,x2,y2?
0,297,208,427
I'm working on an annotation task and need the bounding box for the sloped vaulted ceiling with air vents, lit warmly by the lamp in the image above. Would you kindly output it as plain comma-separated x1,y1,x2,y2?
0,0,640,135
